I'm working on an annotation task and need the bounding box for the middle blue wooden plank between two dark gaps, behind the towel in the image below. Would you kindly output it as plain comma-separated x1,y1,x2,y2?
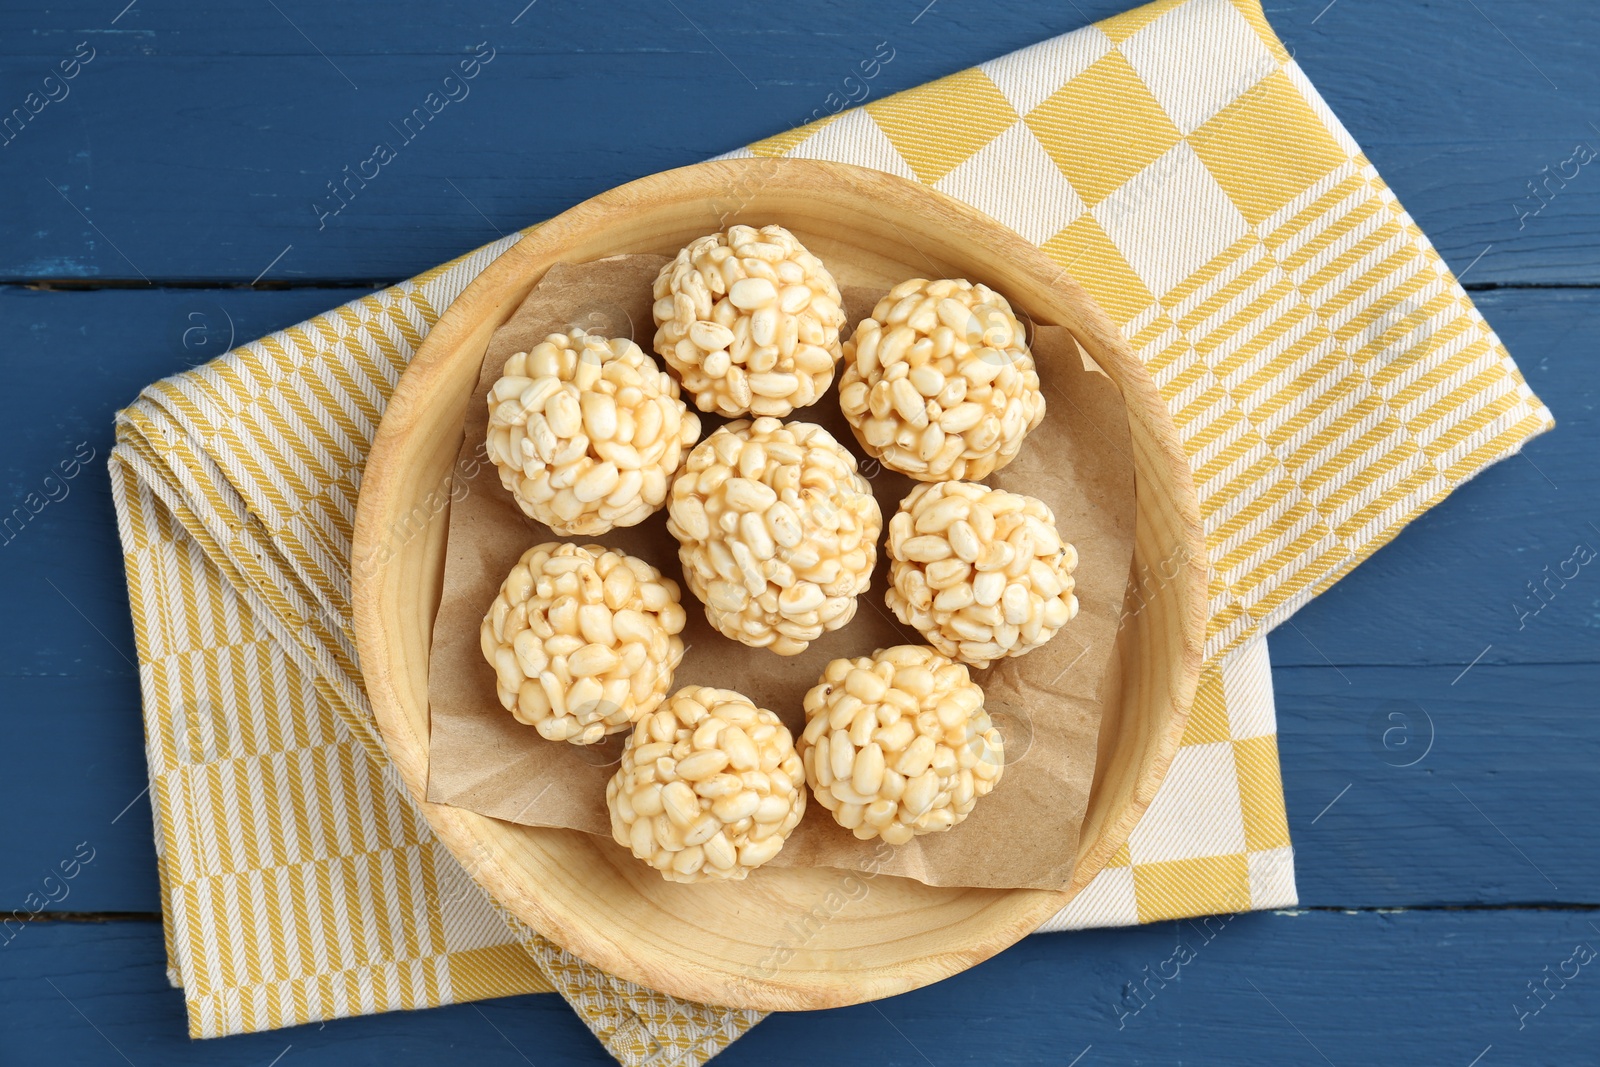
0,288,1600,910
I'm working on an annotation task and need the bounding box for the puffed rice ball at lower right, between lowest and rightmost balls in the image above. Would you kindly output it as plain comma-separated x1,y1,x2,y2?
800,645,1005,845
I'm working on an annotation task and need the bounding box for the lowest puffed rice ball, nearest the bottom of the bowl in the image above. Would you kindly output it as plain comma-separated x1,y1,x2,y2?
605,686,805,881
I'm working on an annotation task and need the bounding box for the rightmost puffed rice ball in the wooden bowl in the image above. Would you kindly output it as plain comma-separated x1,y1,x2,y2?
885,482,1078,667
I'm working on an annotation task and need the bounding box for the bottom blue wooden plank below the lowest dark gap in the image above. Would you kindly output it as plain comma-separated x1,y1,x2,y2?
0,910,1600,1067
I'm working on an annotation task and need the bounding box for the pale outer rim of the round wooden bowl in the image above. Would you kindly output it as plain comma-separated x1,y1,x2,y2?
352,157,1208,1011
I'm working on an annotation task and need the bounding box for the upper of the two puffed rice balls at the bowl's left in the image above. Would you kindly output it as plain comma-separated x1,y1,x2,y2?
488,330,699,536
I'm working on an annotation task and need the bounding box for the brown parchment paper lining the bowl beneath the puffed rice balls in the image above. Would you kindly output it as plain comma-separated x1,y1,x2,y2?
427,256,1134,889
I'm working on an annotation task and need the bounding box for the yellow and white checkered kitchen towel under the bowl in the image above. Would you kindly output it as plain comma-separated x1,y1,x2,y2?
112,0,1552,1064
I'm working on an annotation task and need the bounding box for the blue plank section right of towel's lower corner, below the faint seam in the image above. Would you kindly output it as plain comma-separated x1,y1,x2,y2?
1272,664,1600,907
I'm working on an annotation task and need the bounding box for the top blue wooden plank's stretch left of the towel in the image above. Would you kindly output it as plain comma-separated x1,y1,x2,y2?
0,0,1118,280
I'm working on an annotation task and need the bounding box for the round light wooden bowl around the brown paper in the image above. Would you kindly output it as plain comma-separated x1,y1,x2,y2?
354,160,1206,1011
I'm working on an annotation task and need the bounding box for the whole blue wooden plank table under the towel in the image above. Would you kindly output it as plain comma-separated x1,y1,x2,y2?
0,0,1600,1067
